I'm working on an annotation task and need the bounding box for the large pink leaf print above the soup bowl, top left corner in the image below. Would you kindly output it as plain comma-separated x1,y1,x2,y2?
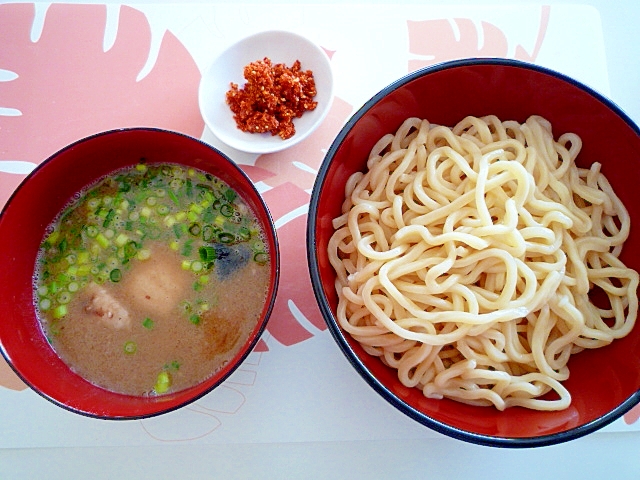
0,4,204,205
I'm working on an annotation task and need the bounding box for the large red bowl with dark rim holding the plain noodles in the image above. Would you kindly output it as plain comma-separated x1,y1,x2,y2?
307,59,640,447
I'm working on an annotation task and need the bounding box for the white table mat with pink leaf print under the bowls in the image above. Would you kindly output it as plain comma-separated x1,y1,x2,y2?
0,3,640,448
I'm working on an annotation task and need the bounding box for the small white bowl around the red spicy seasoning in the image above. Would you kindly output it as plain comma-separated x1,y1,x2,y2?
198,30,333,153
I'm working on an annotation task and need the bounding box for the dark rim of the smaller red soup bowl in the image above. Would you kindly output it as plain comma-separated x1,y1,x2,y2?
0,126,280,421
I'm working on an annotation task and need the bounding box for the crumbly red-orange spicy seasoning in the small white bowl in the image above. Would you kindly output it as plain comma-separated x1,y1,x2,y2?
226,57,318,140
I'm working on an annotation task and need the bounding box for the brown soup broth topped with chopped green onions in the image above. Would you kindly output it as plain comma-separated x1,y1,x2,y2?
34,163,270,395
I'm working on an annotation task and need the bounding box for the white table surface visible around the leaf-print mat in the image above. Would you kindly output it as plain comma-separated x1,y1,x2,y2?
0,0,640,479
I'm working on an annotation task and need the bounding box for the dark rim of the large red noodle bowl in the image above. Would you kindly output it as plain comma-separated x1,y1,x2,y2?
306,57,640,448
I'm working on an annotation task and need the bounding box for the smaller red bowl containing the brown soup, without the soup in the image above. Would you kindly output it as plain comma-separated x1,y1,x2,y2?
0,128,279,419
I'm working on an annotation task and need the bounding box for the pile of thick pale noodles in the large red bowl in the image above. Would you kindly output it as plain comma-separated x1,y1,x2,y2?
328,116,638,410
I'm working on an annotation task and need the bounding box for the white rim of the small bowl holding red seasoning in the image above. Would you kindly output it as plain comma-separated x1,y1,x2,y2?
198,29,335,155
